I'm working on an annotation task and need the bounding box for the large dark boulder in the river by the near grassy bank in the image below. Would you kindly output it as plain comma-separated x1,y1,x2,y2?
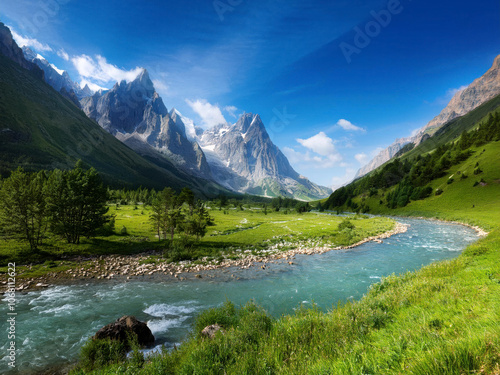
92,316,155,346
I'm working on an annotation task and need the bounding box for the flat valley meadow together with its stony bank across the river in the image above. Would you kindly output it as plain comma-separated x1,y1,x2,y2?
0,212,398,292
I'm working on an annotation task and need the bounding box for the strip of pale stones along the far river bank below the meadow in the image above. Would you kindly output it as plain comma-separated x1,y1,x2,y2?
1,222,408,293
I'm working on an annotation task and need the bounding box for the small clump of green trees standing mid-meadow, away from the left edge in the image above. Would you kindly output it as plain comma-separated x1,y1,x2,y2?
150,188,213,240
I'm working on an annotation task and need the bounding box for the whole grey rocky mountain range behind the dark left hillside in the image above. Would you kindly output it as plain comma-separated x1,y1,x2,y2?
0,24,331,200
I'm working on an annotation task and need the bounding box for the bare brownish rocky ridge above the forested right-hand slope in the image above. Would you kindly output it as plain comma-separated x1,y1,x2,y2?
355,55,500,178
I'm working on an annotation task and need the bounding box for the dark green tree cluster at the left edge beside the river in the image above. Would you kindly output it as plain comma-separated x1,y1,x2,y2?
0,162,110,251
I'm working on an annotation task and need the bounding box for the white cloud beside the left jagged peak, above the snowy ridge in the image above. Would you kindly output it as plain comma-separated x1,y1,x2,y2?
71,55,143,87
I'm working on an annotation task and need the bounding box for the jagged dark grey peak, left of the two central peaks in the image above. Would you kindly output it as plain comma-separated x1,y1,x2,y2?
81,69,212,179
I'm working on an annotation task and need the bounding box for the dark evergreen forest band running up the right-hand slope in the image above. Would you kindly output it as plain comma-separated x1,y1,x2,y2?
325,113,500,212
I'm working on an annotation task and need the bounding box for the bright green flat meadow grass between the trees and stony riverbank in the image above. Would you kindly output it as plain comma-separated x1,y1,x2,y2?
0,209,394,279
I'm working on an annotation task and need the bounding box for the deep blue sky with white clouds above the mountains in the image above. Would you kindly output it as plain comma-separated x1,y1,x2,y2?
0,0,500,186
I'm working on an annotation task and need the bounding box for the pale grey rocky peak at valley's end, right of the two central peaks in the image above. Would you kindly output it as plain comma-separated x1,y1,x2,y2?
198,113,331,200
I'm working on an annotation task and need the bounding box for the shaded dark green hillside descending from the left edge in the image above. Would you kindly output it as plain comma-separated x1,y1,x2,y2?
0,55,225,196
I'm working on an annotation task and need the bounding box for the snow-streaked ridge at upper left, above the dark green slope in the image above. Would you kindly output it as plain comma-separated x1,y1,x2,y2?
22,47,94,105
